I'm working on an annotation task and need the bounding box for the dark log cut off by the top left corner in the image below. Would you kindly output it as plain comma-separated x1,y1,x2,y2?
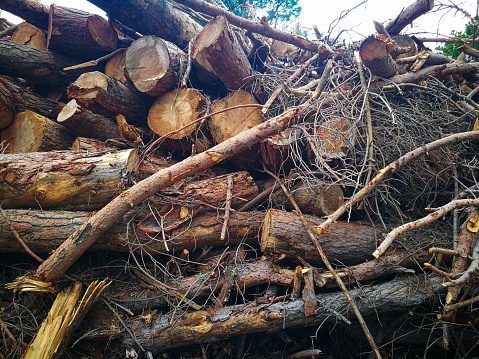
0,0,50,30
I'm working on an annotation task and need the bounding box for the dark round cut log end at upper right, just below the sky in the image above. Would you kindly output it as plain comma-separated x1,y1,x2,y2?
359,35,399,77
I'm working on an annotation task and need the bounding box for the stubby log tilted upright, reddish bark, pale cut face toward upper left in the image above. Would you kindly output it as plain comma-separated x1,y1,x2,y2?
193,16,253,90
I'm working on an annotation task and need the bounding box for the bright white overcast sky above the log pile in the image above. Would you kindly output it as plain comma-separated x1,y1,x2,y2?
0,0,479,42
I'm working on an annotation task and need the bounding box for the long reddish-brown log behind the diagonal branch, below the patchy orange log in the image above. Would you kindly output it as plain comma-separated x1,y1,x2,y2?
0,208,264,253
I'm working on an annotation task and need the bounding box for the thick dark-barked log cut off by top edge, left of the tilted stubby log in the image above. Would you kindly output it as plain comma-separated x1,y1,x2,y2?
86,0,202,49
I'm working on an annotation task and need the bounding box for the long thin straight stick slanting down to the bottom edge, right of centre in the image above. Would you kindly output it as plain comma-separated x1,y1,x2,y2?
264,168,381,359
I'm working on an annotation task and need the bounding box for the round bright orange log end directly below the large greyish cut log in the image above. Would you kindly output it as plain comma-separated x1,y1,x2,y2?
148,88,206,140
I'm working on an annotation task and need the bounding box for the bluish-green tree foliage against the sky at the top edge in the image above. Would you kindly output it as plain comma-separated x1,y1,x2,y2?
223,0,301,27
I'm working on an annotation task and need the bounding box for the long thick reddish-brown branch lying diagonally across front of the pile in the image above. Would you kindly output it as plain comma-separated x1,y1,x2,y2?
26,111,297,282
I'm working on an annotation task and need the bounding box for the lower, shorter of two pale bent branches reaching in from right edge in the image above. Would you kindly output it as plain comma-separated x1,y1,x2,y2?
373,199,479,258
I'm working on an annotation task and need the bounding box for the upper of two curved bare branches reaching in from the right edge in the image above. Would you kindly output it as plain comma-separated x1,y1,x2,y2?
317,131,479,245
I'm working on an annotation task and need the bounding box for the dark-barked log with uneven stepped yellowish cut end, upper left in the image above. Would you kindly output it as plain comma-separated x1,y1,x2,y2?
68,71,153,125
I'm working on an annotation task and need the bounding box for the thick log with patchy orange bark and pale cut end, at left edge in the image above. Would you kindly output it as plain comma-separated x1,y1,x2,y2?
0,149,138,210
